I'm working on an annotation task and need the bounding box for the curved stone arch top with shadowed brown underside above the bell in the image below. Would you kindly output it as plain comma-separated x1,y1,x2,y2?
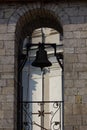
8,3,63,41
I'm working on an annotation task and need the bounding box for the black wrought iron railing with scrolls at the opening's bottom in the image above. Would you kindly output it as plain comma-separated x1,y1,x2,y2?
23,101,63,130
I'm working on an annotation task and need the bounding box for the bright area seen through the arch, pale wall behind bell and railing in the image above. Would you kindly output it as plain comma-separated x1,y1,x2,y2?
22,27,63,130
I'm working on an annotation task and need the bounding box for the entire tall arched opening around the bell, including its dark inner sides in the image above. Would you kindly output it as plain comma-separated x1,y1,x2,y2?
16,10,63,130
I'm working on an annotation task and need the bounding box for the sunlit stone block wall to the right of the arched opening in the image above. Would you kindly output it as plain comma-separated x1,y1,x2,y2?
64,24,87,130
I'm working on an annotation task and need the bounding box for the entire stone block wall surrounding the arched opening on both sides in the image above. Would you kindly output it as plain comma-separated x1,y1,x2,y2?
0,2,87,130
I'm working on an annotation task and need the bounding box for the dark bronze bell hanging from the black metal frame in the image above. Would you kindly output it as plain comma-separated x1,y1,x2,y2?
32,44,52,69
